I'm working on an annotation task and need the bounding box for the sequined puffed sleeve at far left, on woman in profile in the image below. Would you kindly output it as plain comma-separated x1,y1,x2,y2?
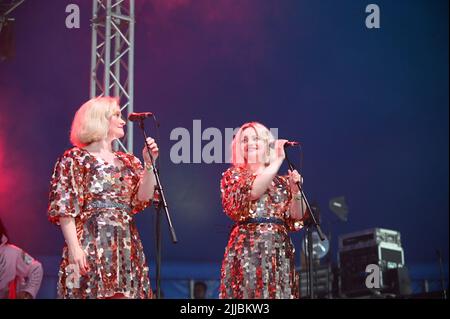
47,153,84,225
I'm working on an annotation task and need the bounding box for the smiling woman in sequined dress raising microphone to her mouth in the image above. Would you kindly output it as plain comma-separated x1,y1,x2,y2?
220,122,306,299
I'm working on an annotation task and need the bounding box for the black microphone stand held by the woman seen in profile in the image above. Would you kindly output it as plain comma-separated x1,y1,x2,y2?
139,118,178,299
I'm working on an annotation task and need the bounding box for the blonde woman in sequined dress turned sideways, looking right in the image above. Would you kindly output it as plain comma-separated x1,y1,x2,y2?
48,97,159,299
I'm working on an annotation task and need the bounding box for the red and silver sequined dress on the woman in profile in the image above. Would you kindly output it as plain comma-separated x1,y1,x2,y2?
48,147,156,299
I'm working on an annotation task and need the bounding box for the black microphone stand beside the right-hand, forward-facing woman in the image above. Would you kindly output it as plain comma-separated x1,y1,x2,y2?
284,147,325,299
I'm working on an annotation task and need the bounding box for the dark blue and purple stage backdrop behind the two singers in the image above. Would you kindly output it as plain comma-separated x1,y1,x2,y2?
0,0,449,300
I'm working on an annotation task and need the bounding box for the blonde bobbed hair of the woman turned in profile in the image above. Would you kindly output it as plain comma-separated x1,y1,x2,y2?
70,96,119,147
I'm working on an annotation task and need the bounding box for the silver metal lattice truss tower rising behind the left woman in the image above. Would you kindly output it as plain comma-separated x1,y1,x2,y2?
90,0,135,153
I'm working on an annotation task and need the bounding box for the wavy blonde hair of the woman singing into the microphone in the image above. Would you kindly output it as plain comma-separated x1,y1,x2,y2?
231,122,275,166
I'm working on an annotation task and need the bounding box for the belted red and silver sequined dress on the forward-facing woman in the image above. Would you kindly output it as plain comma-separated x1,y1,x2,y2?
220,167,299,299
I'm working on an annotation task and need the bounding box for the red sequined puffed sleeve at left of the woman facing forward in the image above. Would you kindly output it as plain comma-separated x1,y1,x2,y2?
220,167,256,221
